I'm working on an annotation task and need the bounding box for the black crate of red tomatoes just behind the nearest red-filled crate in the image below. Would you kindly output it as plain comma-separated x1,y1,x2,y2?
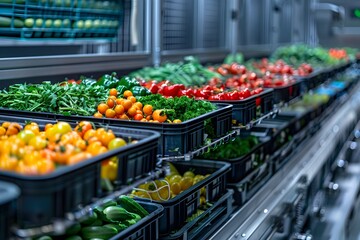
272,79,302,104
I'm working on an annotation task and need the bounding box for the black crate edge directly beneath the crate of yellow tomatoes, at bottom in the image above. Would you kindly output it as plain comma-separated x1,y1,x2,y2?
161,190,233,240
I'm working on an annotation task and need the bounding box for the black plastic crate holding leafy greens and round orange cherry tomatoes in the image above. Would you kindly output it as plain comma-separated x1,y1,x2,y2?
0,104,232,156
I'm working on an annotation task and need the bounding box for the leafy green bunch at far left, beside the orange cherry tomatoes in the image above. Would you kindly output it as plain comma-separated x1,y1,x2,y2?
0,82,108,116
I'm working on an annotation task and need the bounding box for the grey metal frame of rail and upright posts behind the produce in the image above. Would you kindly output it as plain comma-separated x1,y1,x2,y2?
0,0,314,80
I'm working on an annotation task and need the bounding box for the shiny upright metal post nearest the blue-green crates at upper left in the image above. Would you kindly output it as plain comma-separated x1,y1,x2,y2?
151,0,162,66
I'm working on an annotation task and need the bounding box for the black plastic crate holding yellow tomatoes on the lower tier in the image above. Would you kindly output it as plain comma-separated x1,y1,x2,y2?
134,160,230,236
